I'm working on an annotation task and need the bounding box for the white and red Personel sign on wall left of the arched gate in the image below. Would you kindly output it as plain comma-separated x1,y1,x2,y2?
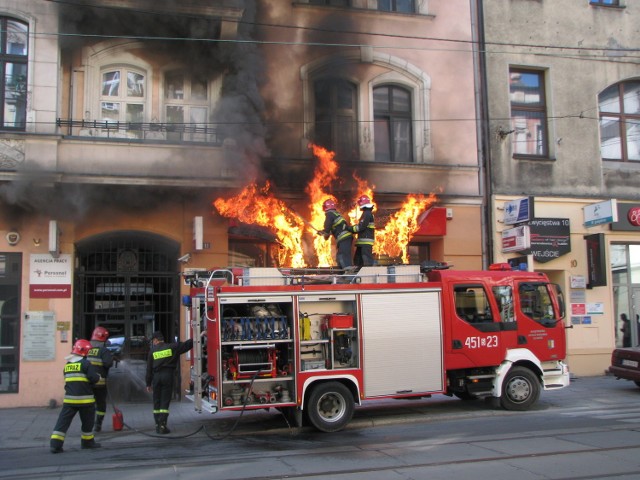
29,253,72,298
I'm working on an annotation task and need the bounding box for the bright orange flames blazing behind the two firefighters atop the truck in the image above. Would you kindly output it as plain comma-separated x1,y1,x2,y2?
213,145,437,268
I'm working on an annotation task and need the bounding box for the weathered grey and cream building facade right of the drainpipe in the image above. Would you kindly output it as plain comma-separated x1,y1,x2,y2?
478,0,640,375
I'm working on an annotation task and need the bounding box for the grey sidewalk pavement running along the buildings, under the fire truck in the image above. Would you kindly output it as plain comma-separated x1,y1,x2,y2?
0,375,636,452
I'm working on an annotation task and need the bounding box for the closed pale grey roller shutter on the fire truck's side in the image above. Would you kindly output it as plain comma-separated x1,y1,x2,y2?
362,290,444,398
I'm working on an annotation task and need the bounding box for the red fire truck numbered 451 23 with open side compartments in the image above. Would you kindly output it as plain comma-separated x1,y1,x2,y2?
183,264,569,432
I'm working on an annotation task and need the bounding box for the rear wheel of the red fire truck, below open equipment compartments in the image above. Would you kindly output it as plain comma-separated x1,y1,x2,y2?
307,382,355,432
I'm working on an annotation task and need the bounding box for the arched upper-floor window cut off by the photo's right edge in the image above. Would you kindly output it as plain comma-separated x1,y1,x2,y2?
598,80,640,162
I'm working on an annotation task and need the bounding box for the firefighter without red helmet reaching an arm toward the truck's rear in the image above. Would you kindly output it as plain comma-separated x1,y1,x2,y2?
146,330,206,434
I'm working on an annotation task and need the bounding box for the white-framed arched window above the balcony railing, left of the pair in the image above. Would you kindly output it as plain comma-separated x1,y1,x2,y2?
100,68,147,123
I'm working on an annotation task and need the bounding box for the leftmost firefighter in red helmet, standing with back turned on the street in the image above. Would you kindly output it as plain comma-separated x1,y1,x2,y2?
49,340,100,453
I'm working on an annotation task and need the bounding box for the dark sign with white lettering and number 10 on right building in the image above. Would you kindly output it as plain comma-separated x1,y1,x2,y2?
529,218,571,263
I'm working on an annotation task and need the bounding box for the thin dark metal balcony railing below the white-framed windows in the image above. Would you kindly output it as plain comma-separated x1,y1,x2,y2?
56,118,222,146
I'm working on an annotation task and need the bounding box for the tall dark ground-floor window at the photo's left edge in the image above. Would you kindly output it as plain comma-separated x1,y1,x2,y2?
0,253,22,393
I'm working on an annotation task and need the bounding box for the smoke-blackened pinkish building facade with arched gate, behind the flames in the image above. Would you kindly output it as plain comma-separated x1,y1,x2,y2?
0,0,480,408
